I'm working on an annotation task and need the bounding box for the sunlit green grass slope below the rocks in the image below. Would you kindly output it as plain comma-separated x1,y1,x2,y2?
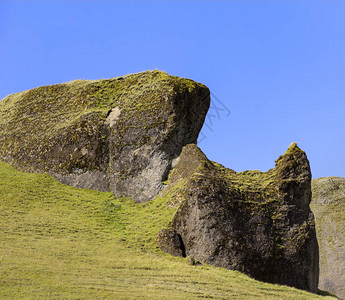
0,162,328,299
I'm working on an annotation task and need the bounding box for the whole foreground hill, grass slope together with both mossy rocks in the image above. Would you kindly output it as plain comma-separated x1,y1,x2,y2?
0,70,342,299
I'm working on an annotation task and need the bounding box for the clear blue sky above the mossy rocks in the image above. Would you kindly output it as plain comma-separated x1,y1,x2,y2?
0,0,345,178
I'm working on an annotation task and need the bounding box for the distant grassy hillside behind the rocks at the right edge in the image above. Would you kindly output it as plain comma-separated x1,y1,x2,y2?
311,177,345,299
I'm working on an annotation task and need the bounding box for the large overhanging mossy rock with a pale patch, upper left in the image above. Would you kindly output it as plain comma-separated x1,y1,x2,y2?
0,71,210,202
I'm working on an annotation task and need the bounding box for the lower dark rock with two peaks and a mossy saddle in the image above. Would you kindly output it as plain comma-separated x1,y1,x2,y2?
160,144,319,293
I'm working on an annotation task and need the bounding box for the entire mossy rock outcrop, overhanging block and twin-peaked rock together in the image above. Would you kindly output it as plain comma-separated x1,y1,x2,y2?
0,71,319,292
